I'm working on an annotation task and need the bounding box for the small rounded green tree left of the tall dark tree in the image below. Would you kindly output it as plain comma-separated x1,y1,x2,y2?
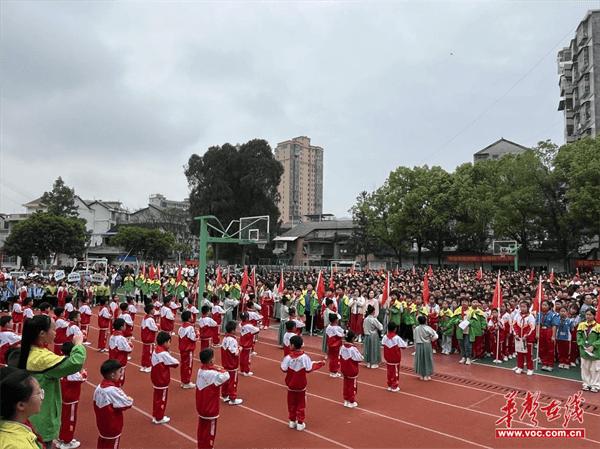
111,226,176,263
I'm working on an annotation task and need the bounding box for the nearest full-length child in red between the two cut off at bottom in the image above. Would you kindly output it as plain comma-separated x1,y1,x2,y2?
150,331,179,424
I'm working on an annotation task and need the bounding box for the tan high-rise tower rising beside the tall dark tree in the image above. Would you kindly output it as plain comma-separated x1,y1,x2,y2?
275,136,323,223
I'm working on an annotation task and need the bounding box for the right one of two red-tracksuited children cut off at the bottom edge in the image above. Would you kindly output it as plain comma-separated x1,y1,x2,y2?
196,348,229,449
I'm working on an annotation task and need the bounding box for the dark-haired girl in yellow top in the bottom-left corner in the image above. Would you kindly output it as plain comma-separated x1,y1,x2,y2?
0,366,44,449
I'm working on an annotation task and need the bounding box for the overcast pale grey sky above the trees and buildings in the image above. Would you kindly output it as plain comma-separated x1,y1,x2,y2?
0,0,600,216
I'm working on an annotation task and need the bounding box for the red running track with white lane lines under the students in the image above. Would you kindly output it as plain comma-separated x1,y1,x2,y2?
45,317,600,449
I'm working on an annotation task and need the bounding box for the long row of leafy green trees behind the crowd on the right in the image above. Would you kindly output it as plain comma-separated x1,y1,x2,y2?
351,139,600,263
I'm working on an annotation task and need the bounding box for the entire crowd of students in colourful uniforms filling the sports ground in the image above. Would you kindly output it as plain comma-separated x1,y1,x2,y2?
0,268,600,449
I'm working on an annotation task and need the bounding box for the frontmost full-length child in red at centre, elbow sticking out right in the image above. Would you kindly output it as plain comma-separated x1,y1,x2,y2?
281,335,325,430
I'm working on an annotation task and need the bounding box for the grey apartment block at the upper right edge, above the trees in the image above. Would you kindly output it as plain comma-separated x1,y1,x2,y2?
558,10,600,142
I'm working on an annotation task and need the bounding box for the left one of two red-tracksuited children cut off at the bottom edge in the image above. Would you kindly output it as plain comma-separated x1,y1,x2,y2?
94,359,133,449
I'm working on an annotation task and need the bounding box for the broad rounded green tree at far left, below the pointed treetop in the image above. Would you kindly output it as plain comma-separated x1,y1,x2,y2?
4,213,88,266
